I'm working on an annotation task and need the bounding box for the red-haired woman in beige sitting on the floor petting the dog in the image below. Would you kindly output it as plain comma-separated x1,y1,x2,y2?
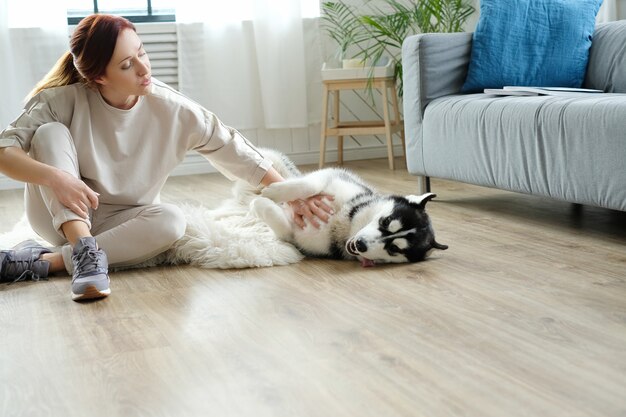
0,15,331,300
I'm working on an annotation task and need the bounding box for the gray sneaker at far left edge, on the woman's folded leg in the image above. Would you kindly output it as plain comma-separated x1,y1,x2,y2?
0,240,51,284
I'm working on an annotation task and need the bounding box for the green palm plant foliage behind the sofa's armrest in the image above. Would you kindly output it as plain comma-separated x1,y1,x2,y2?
321,0,475,96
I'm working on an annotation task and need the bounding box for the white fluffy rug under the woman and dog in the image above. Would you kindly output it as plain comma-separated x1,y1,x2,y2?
0,199,304,269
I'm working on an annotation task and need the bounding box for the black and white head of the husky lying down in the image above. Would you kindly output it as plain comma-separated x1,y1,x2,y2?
346,193,448,266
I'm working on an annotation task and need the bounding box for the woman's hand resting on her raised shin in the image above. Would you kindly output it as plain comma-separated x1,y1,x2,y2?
50,170,98,219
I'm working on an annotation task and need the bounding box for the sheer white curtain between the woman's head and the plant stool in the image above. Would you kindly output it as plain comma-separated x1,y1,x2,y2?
176,0,320,129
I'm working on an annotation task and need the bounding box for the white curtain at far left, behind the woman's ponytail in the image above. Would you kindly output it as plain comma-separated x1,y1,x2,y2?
0,0,69,126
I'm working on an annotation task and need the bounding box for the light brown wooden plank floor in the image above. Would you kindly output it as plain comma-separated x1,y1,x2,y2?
0,159,626,417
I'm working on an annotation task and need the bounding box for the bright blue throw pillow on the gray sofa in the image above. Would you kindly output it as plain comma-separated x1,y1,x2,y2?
463,0,602,92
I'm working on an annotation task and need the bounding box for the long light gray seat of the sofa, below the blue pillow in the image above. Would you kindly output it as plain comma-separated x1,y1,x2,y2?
421,94,626,210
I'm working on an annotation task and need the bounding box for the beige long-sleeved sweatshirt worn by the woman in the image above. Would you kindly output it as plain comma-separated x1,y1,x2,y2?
0,78,272,205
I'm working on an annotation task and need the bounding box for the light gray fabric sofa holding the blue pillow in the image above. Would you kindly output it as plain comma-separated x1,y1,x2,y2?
402,21,626,211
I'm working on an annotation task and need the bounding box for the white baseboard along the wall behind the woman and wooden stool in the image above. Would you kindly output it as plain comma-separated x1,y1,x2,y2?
0,145,403,190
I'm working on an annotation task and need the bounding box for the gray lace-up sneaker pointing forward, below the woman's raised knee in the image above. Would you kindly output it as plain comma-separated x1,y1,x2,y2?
72,237,111,301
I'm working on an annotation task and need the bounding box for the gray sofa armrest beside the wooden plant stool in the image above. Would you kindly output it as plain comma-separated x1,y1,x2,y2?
402,32,472,175
